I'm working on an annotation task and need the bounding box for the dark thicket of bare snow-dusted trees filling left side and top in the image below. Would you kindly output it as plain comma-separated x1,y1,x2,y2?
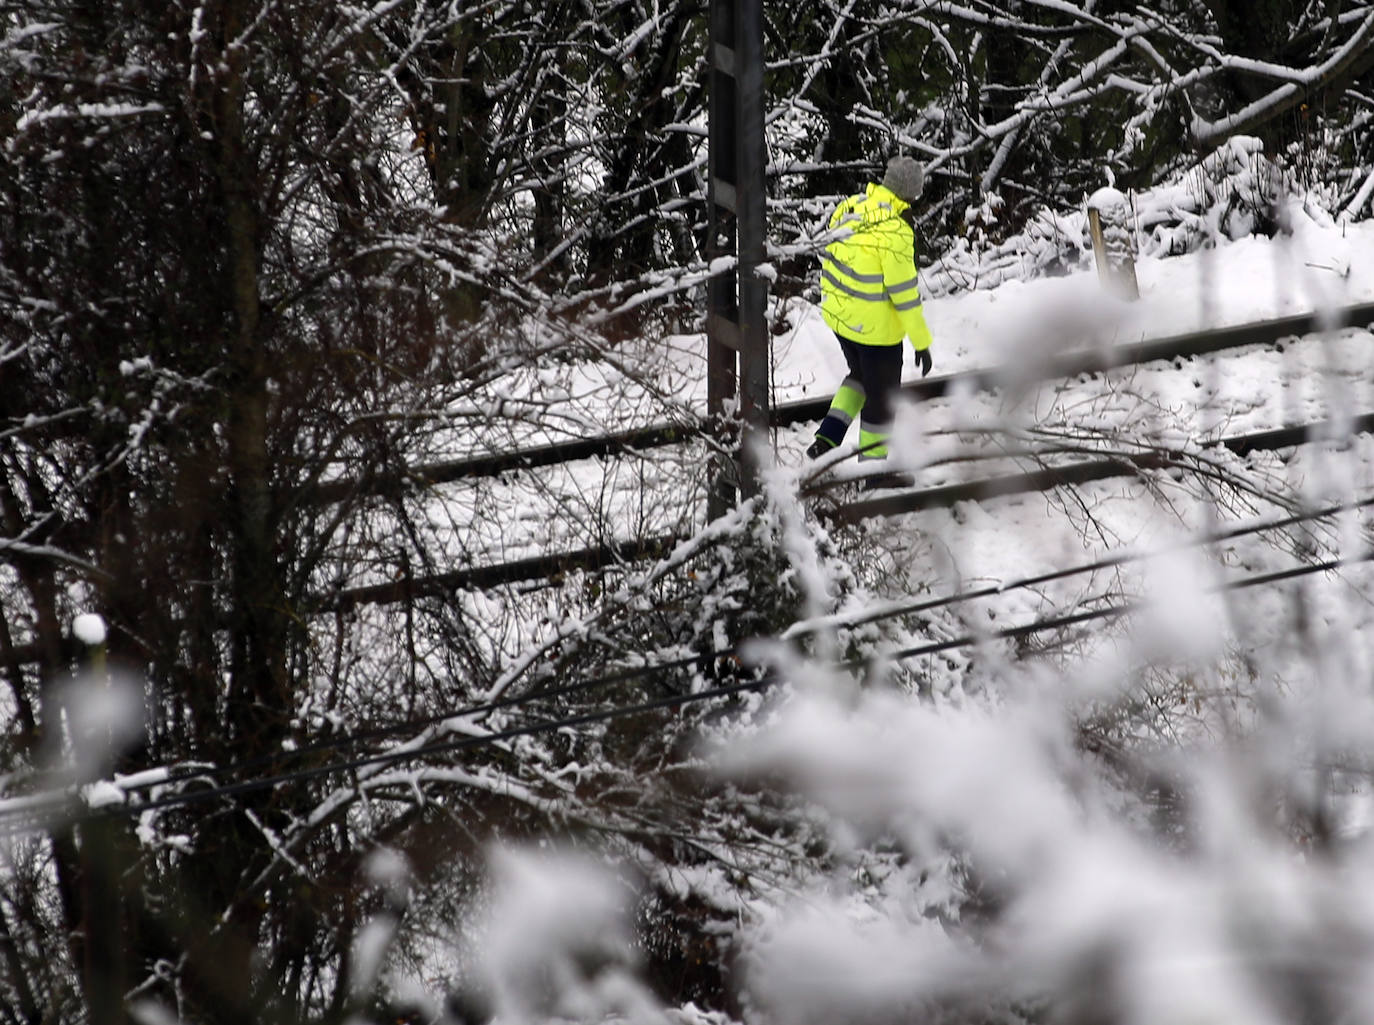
0,0,1374,1025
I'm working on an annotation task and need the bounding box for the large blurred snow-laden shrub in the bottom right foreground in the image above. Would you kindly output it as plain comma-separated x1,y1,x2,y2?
731,579,1374,1025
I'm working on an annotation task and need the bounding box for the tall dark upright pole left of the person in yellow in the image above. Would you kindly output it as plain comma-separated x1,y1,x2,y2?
706,0,768,518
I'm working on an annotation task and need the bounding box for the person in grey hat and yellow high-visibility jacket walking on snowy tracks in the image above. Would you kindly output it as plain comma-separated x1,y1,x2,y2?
807,157,933,489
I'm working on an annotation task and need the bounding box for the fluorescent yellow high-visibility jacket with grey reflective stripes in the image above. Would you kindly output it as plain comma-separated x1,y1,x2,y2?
820,184,932,349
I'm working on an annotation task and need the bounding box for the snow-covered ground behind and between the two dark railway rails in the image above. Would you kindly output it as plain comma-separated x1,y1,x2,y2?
434,192,1374,579
